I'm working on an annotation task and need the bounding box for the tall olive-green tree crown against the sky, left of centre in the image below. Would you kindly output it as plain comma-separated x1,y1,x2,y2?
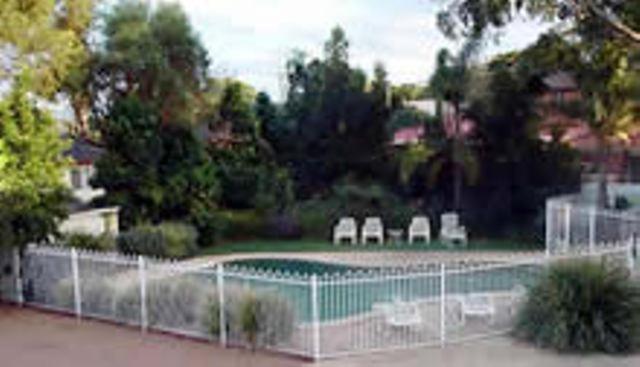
93,0,209,123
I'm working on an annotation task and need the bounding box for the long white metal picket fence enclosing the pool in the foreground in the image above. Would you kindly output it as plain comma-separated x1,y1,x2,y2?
2,244,634,359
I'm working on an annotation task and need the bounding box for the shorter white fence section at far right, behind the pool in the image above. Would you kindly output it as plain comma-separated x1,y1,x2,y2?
546,195,640,255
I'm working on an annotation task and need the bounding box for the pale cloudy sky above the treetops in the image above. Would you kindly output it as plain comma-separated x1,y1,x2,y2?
151,0,546,100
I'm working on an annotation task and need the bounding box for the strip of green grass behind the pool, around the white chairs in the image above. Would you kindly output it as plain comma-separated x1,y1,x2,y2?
198,239,544,256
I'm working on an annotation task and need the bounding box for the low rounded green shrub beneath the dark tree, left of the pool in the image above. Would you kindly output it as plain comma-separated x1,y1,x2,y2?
117,222,198,258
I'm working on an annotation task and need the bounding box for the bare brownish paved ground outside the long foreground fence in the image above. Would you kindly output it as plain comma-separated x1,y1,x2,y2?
0,305,640,367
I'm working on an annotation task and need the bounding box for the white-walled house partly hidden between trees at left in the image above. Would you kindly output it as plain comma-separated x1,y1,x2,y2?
59,137,119,235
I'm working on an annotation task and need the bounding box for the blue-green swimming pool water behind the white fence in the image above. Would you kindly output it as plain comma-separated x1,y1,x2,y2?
222,258,542,321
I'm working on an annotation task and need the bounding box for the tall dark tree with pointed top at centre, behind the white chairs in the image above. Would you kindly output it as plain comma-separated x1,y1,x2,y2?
283,27,393,197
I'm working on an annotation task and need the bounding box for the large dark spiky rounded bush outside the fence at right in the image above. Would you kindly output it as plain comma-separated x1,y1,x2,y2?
515,261,640,353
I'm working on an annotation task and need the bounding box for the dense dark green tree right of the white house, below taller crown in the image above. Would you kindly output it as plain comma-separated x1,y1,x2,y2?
93,96,219,233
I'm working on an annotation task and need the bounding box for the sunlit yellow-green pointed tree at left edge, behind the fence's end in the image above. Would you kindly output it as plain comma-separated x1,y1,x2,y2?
0,76,68,246
